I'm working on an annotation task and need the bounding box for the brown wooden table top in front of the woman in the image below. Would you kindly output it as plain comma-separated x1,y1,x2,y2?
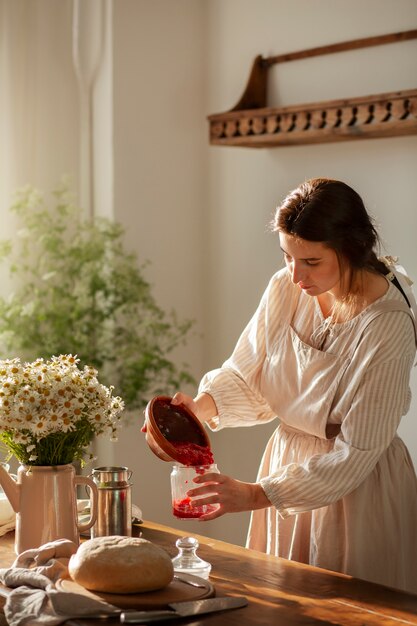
0,521,417,626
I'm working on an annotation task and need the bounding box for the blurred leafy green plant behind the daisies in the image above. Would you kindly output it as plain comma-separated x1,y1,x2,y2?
0,183,194,409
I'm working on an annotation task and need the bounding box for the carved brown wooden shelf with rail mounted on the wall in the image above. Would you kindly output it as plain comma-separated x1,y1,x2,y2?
208,30,417,148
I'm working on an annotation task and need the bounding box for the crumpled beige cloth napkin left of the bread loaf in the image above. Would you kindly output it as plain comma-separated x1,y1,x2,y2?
0,539,120,626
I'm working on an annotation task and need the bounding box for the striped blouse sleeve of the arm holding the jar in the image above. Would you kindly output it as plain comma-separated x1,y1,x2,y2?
260,312,415,517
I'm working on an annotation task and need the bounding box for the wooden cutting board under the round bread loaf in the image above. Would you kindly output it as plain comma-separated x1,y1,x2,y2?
56,574,215,610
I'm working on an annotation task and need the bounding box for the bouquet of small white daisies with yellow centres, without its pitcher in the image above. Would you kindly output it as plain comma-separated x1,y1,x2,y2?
0,354,124,465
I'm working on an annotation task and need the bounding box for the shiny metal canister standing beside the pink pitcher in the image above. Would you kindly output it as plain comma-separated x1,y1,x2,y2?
90,466,132,538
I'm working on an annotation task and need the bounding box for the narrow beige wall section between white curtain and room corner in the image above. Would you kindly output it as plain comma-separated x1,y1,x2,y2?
109,0,208,536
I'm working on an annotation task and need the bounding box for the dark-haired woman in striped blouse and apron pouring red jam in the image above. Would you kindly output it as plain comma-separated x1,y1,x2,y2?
173,179,417,592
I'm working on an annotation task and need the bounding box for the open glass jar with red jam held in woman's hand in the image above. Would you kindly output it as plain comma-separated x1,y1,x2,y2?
171,463,220,519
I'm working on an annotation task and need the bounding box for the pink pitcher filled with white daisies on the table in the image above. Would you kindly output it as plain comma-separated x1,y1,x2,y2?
0,354,123,554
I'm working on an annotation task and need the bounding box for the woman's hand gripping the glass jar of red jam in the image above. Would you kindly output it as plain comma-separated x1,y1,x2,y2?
187,473,271,521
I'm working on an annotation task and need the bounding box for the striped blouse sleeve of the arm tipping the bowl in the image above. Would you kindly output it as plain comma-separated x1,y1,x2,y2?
199,270,289,430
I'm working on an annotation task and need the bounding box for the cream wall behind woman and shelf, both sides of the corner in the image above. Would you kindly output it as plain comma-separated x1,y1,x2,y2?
110,0,417,543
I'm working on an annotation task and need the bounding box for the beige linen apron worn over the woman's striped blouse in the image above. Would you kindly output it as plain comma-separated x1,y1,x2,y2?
247,300,417,591
